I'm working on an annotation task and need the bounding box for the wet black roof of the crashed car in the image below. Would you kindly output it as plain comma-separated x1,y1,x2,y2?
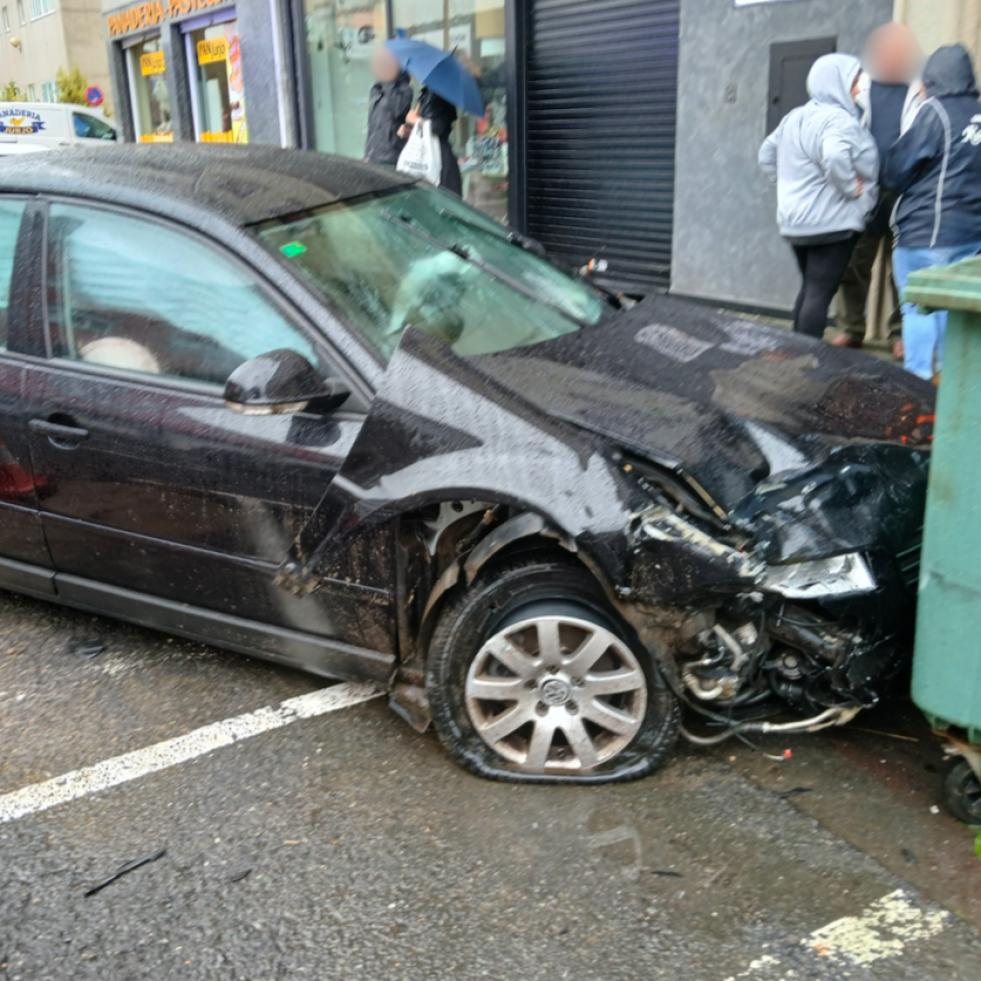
0,143,413,226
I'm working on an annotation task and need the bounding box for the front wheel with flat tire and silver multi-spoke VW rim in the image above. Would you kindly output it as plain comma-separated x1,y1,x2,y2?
427,559,679,783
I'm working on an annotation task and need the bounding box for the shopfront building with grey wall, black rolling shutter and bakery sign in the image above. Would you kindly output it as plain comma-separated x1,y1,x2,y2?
103,0,944,311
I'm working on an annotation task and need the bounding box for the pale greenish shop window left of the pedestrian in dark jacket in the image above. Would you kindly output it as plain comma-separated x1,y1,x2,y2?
304,0,386,160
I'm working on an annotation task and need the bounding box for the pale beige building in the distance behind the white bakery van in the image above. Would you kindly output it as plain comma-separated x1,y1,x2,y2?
0,0,113,112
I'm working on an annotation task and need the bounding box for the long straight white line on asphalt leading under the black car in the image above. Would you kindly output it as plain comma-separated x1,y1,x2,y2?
0,682,382,824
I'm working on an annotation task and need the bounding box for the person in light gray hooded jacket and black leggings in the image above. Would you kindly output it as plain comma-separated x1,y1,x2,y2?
759,54,879,338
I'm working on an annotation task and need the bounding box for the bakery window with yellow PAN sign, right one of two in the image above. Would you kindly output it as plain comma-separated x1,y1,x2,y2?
185,20,249,143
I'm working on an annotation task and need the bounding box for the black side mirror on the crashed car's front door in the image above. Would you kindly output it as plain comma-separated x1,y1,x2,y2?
225,348,351,416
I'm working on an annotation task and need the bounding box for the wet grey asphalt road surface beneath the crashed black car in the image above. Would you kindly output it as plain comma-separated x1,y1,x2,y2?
0,593,981,981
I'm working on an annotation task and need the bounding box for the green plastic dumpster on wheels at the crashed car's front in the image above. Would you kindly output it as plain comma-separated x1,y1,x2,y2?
903,258,981,824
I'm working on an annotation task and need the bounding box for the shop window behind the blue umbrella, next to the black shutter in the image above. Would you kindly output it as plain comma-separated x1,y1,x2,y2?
392,0,508,221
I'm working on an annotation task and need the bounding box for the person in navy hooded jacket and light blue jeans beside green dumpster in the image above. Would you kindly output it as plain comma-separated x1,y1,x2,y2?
883,44,981,378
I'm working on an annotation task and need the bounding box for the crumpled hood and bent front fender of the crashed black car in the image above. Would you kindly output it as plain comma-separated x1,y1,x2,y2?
280,297,933,591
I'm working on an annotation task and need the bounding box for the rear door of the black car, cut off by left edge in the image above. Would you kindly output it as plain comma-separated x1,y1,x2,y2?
0,191,54,595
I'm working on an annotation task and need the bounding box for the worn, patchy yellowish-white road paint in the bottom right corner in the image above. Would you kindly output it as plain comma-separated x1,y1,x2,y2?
726,889,950,981
